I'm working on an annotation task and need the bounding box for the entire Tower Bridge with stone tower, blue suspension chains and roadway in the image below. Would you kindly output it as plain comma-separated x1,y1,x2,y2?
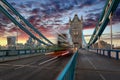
0,0,120,80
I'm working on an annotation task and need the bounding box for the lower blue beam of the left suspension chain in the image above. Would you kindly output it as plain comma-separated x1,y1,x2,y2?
0,5,48,46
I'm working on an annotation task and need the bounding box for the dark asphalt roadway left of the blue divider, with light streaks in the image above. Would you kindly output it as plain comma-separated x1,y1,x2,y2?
0,52,71,80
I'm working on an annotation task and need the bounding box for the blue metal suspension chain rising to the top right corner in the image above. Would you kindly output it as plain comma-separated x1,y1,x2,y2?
88,0,120,46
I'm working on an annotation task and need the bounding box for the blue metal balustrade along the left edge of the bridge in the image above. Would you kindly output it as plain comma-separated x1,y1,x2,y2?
0,49,52,62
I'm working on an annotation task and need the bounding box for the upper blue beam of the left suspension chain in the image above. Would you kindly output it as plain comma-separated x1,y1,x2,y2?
1,0,54,45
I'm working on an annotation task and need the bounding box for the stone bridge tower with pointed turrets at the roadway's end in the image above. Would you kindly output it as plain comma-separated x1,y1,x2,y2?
69,14,83,48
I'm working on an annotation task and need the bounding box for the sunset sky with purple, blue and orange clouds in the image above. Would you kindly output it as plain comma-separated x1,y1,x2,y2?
0,0,120,45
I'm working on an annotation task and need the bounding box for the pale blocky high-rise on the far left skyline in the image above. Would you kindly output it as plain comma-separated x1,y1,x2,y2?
7,36,16,49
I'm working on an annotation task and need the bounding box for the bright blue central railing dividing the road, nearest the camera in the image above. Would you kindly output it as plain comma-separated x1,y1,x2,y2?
57,51,78,80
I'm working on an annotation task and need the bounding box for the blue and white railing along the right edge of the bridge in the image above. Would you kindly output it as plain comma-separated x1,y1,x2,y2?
89,49,120,60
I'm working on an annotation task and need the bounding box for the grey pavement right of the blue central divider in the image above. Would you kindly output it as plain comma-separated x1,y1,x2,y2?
75,50,120,80
